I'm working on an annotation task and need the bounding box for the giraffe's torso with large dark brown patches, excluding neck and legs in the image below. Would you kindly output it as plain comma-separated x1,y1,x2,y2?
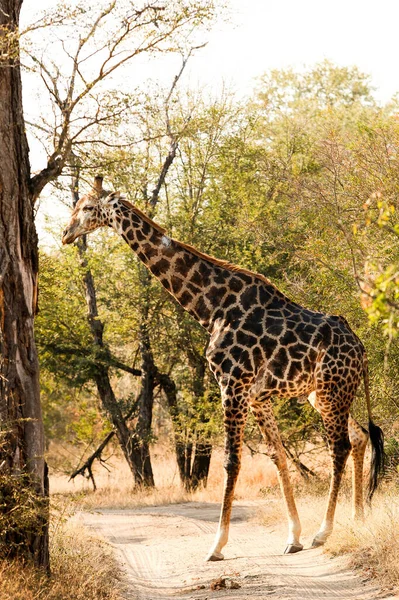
207,280,364,397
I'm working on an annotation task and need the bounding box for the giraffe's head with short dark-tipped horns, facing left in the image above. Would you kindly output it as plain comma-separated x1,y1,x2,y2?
62,176,109,244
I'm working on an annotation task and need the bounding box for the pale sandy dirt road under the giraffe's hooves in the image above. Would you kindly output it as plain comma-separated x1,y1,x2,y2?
78,503,393,600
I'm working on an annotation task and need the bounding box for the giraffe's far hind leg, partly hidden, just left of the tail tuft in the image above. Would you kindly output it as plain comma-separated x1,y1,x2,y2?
348,416,368,519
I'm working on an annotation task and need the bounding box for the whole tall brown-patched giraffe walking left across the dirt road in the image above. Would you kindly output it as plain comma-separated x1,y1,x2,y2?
62,176,384,561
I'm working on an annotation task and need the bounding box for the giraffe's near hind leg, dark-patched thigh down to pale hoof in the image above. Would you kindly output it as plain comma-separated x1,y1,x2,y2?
309,391,351,548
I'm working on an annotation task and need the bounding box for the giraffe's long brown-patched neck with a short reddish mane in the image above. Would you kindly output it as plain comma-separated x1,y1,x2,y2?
108,199,260,331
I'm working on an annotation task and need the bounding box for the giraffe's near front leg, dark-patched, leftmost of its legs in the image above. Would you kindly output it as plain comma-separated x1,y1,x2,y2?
206,393,248,561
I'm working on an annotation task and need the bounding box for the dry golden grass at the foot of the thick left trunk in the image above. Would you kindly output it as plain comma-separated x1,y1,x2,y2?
0,522,121,600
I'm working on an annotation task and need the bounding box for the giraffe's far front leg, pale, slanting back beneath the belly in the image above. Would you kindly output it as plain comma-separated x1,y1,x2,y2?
251,398,303,554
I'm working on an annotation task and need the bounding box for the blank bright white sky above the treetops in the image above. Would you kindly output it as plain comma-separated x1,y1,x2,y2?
22,0,399,244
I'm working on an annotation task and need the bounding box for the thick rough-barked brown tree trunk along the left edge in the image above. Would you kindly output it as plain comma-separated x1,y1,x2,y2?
0,0,49,569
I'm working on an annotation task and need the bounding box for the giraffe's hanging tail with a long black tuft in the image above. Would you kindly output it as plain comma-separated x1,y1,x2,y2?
363,354,385,502
